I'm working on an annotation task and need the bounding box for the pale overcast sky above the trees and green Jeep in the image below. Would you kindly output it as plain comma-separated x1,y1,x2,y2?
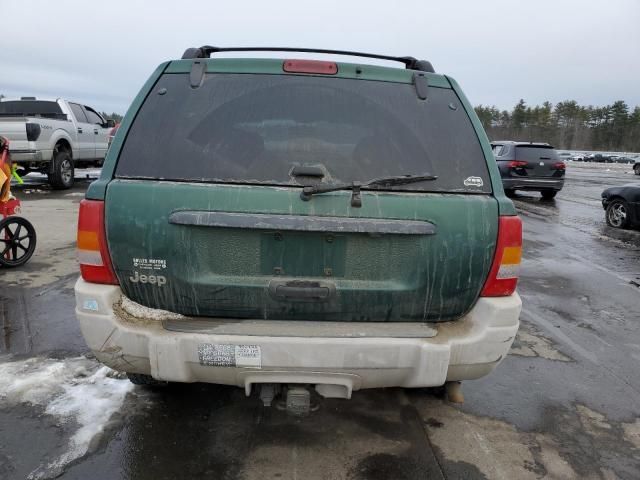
0,0,640,113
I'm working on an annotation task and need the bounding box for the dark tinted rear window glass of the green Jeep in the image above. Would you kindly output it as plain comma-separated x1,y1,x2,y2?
116,74,491,192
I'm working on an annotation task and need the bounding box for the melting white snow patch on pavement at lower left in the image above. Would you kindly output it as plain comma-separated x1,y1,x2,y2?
0,357,134,479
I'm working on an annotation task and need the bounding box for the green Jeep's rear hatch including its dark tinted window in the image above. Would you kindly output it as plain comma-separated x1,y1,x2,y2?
106,60,498,321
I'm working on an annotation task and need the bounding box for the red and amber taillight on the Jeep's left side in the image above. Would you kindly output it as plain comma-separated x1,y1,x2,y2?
78,200,118,285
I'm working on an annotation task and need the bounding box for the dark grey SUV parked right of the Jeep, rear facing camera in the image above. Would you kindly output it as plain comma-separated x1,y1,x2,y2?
491,140,566,200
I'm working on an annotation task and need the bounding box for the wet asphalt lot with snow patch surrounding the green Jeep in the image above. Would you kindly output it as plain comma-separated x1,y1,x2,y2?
0,164,640,480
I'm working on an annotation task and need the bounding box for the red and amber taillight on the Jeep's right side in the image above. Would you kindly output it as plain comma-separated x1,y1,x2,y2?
481,216,522,297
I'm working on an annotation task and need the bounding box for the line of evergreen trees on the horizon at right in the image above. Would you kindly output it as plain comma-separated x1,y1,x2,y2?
475,99,640,152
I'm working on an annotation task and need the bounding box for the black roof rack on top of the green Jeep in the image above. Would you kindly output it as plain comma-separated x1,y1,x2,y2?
182,45,435,73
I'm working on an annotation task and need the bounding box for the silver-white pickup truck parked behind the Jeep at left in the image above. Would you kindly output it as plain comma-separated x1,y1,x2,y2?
0,97,114,189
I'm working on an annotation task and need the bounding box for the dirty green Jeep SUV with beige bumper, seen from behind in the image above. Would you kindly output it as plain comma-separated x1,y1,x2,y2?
75,47,522,398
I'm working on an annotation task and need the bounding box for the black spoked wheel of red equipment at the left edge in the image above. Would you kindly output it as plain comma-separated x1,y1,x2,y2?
0,216,36,267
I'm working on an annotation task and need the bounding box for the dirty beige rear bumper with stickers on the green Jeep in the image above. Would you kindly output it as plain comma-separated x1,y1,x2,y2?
75,279,521,398
